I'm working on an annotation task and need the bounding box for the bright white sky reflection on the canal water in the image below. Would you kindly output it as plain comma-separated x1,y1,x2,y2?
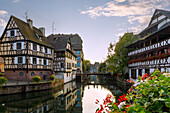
82,85,113,113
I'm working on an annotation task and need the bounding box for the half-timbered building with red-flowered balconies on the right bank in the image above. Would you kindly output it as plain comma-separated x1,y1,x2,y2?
127,9,170,79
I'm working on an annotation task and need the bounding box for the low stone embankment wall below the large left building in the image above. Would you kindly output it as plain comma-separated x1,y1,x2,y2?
0,79,64,95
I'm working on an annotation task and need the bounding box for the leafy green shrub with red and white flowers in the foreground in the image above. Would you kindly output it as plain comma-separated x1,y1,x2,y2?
96,70,170,113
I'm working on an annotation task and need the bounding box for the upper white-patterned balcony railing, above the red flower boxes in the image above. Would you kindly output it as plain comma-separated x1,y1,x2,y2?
128,39,170,56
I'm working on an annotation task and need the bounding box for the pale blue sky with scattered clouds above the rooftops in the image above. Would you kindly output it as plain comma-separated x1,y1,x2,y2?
0,0,170,63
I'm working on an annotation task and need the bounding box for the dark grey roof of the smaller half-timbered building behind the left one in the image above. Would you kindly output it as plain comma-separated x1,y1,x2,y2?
47,34,70,51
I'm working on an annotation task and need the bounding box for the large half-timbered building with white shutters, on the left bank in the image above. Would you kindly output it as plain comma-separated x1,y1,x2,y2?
0,16,53,81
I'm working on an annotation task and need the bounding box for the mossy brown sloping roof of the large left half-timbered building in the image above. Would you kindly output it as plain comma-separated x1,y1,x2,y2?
2,16,52,47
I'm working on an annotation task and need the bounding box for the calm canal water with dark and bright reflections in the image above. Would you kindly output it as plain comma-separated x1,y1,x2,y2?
0,75,127,113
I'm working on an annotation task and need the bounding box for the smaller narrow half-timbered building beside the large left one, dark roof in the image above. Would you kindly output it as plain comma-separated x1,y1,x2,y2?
47,34,77,83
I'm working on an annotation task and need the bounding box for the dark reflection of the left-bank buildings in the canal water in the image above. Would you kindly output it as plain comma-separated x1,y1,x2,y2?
0,81,82,113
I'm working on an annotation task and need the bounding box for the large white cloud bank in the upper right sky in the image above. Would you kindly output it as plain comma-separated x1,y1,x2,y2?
80,0,170,32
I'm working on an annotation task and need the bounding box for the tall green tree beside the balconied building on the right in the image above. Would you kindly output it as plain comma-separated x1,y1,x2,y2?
106,33,136,74
